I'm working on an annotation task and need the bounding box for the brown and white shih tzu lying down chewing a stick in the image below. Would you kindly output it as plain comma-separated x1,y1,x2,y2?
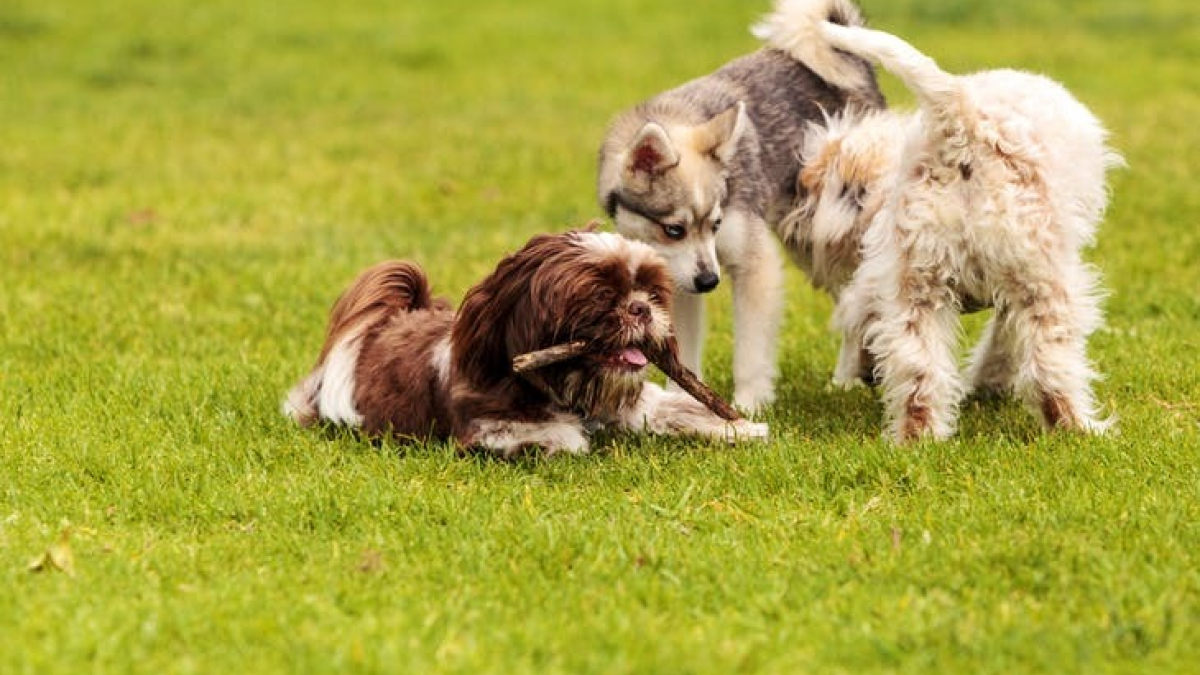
283,231,768,458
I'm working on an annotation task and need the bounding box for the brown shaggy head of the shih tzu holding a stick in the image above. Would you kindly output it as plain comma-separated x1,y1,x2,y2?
452,232,671,418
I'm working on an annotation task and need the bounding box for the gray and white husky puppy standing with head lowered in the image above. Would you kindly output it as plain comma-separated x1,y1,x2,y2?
596,0,883,411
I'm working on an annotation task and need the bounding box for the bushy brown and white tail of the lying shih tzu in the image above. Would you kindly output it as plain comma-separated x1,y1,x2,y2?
283,261,434,426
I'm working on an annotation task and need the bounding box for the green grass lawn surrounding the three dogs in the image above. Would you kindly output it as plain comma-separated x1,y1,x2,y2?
0,0,1200,675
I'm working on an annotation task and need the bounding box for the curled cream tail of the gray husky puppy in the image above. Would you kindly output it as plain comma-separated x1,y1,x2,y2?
750,0,872,91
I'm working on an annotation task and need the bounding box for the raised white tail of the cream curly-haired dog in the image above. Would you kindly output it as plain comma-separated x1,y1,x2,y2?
818,22,959,108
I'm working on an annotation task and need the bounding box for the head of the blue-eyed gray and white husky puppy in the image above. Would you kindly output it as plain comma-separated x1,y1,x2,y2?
604,103,745,293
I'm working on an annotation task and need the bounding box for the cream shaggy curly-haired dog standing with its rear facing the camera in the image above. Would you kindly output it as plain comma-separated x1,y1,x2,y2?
782,23,1121,442
